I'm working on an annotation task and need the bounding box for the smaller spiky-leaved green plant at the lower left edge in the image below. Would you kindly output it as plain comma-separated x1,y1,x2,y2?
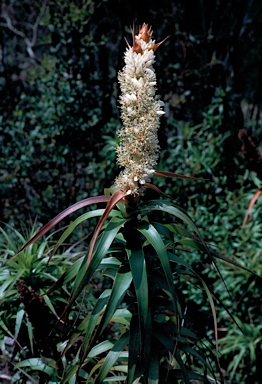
0,224,98,382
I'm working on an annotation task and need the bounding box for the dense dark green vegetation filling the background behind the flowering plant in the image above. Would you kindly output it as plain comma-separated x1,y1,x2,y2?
0,0,262,383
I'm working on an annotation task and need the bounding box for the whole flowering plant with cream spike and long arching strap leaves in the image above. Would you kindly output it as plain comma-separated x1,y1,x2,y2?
4,24,260,384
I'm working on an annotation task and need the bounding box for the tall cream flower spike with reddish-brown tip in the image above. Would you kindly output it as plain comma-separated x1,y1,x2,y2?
115,24,165,195
